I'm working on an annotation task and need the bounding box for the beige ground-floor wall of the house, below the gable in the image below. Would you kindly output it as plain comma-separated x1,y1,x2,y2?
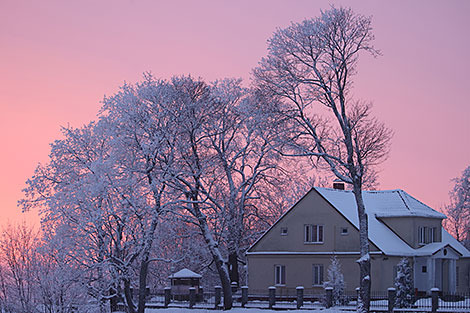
248,255,401,294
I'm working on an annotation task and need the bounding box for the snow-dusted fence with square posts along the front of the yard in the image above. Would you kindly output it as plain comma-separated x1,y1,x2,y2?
140,286,470,313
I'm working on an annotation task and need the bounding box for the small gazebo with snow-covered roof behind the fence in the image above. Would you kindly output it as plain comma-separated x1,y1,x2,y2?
168,268,202,300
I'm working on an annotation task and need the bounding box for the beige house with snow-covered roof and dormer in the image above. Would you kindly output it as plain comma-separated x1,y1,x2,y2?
247,186,470,294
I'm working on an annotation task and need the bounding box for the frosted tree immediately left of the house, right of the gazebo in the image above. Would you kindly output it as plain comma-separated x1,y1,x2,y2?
204,79,294,284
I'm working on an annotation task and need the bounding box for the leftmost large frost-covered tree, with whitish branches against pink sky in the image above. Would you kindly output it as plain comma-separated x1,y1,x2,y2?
20,123,127,312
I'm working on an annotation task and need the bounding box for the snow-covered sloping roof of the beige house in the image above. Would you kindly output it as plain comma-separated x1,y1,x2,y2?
315,187,470,257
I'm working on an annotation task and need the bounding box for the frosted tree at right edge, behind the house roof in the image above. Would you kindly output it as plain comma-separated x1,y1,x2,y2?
444,166,470,248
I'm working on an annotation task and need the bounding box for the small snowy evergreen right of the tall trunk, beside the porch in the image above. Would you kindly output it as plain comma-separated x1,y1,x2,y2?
395,258,414,308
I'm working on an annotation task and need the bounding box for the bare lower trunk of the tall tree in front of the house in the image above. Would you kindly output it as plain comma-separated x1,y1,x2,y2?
353,182,371,313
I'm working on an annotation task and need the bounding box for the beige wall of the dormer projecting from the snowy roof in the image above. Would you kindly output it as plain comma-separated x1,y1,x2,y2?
380,217,442,249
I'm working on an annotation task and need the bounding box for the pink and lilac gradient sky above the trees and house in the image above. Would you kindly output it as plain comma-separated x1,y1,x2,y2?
0,0,470,226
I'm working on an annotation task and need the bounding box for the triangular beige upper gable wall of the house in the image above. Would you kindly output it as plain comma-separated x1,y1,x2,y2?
250,191,378,252
